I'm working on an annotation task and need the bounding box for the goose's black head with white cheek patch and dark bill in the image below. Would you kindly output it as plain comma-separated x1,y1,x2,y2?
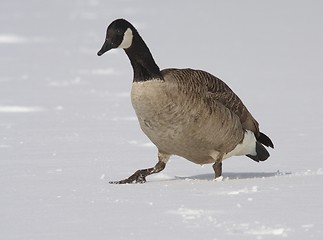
98,19,136,56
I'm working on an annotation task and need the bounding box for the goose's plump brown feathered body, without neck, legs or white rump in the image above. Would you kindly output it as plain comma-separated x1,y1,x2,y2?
131,69,258,164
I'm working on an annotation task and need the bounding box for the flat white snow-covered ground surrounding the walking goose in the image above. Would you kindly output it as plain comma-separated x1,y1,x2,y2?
0,0,323,240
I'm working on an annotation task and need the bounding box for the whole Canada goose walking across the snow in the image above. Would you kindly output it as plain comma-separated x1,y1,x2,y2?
97,19,274,184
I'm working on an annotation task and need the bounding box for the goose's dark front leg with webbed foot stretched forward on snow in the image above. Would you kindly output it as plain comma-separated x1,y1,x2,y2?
110,152,170,184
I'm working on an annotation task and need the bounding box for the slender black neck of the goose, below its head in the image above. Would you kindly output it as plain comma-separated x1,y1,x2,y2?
125,30,163,82
